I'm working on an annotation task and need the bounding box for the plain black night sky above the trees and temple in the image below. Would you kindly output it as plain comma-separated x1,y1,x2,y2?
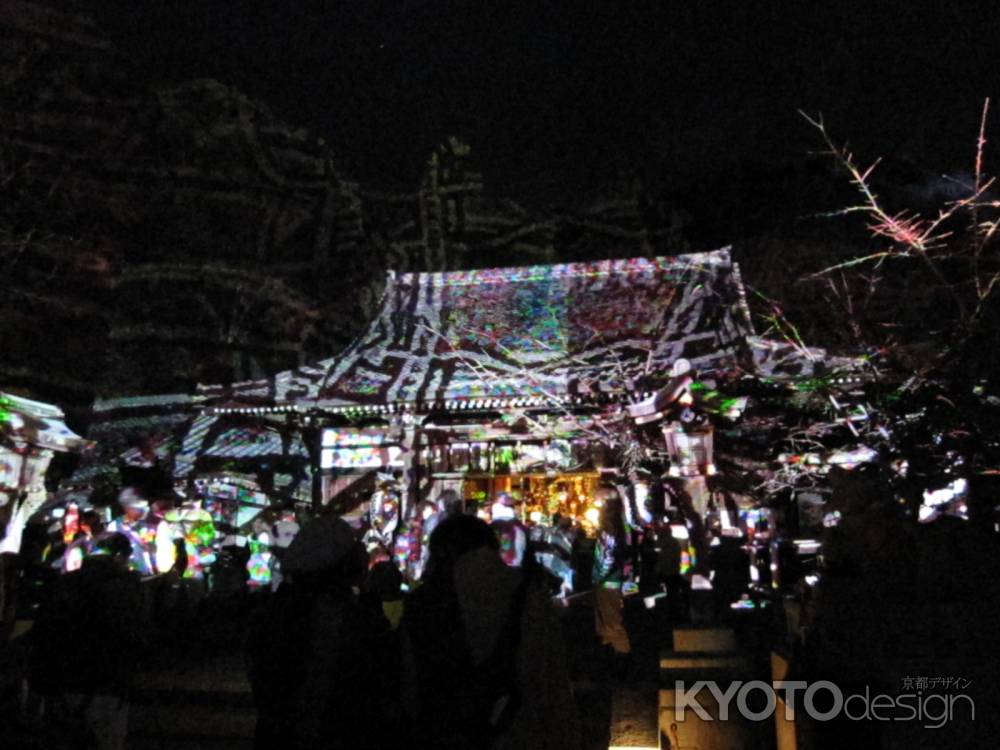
80,0,1000,207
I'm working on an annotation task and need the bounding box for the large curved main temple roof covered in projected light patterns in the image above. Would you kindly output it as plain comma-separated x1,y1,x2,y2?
202,248,753,407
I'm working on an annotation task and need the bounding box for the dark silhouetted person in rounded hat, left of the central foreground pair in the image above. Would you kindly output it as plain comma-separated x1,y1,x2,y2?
247,516,398,750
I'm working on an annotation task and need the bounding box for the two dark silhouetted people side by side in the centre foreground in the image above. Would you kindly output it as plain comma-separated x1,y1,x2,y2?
248,513,579,748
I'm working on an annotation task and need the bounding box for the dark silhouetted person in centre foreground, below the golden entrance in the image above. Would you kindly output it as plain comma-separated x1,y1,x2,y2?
402,515,580,750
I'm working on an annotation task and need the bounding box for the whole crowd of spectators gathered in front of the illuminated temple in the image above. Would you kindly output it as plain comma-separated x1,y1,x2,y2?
9,482,764,748
